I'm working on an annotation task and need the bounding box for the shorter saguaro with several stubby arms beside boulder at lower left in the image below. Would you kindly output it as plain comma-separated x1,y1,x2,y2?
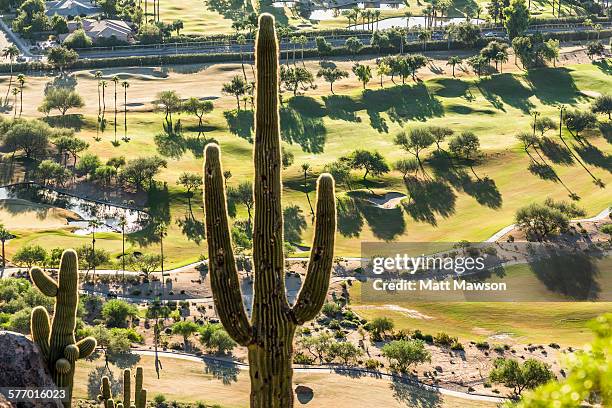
30,249,96,408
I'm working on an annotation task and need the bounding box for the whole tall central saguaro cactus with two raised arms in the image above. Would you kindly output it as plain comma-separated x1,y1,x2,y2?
204,14,336,408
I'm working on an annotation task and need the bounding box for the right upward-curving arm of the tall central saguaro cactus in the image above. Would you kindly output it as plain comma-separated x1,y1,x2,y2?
293,174,336,324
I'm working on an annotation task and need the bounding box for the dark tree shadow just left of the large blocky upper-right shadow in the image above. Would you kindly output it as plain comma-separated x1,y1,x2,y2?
478,74,534,113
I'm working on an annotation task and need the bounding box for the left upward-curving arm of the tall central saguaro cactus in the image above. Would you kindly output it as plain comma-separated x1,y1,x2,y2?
204,143,253,346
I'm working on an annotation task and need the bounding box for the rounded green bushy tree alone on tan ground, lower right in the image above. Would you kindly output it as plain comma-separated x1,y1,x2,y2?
489,358,555,396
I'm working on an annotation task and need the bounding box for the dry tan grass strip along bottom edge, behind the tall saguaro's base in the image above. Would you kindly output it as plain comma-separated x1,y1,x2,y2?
74,356,495,408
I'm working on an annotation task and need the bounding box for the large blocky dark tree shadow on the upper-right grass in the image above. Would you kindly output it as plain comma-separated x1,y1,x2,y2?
527,68,582,105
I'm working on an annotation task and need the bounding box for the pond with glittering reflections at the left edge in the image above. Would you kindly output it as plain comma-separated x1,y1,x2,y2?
0,183,149,235
